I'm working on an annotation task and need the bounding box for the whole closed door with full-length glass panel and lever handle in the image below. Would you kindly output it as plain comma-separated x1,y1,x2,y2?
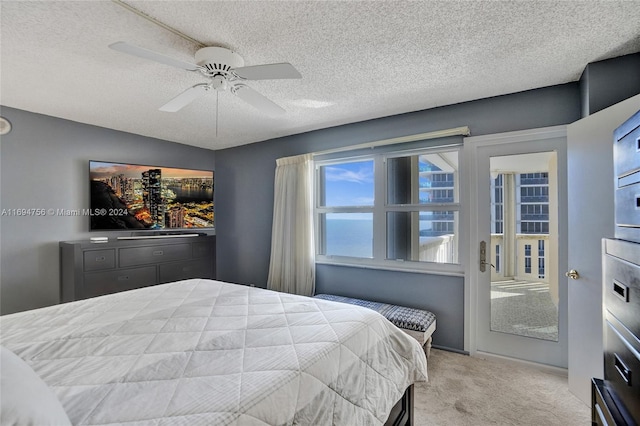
472,138,567,367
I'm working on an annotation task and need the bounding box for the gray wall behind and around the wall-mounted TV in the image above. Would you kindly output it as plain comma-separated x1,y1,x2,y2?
0,107,215,314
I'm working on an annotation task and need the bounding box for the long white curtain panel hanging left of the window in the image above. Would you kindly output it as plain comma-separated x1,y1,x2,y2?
267,154,316,296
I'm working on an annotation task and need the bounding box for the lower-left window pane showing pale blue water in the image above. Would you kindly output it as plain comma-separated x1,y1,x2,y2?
321,213,373,258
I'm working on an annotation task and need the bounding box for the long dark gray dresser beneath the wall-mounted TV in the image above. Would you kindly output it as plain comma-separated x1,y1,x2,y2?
60,235,216,303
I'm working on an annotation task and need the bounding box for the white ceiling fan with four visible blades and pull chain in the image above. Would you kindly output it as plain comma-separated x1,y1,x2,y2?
109,41,302,115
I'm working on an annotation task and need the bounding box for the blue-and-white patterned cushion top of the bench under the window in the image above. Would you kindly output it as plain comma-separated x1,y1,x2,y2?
314,294,436,332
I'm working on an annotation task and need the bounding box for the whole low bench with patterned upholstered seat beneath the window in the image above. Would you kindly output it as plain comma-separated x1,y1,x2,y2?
314,294,436,357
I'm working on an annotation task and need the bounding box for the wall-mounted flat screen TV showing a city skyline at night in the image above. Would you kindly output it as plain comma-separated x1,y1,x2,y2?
89,161,214,231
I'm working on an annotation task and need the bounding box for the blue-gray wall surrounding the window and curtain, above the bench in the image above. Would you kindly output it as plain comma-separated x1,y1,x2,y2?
216,83,580,350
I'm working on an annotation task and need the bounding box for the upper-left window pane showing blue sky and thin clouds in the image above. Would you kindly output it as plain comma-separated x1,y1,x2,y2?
319,160,374,207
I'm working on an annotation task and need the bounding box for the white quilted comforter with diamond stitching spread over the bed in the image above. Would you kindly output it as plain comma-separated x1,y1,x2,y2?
0,279,427,426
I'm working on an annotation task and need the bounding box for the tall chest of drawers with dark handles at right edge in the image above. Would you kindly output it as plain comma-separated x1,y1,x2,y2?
592,111,640,425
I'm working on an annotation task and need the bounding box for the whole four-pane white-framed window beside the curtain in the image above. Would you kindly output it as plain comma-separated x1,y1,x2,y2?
315,147,460,270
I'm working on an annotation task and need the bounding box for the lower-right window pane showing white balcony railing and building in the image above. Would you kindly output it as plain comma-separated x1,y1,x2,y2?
387,211,458,263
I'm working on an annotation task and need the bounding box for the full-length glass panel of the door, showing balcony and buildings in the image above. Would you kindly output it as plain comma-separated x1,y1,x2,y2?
488,152,559,342
